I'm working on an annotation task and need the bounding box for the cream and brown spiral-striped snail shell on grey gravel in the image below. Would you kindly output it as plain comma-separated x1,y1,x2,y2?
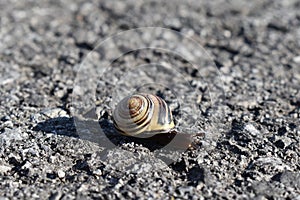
113,93,175,136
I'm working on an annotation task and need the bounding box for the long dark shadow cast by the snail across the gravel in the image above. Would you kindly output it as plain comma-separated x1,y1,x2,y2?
33,117,179,151
